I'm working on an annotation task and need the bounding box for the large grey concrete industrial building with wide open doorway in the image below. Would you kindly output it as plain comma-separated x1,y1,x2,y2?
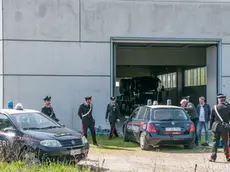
0,0,230,130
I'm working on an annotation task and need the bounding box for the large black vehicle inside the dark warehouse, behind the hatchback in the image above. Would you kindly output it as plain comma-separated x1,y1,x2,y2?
117,76,164,114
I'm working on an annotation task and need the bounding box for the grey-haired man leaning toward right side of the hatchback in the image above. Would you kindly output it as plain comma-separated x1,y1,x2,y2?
180,99,199,145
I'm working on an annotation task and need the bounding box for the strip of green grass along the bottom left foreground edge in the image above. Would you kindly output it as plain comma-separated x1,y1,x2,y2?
0,161,94,172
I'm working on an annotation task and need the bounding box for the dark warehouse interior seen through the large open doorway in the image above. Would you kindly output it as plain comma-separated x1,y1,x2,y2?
114,41,207,113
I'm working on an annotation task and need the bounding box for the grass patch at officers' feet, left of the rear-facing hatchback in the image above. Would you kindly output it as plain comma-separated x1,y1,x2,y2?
88,135,139,148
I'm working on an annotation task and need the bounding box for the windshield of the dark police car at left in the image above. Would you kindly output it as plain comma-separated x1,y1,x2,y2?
12,112,60,130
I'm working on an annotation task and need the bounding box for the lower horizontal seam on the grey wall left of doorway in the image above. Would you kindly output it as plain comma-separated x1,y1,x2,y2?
2,74,110,77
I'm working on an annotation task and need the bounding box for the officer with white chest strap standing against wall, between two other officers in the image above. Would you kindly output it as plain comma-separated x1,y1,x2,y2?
78,96,98,146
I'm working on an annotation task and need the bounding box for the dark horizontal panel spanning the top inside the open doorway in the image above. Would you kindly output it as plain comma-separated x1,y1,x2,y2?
116,47,206,66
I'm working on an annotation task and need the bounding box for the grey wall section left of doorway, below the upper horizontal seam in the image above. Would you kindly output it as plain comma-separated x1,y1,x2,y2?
4,41,110,129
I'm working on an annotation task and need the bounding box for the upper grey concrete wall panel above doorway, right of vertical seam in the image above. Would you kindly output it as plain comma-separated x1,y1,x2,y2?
81,0,230,43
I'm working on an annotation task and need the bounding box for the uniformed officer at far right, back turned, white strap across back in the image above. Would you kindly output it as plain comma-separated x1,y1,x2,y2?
210,94,230,162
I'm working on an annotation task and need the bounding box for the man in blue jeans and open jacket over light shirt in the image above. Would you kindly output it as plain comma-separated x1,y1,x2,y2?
197,97,211,145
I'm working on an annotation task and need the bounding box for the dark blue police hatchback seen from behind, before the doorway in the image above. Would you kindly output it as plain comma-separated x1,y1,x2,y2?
123,105,195,150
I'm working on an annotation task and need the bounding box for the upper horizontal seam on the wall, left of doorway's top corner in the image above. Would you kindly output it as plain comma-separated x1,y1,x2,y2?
2,39,110,43
